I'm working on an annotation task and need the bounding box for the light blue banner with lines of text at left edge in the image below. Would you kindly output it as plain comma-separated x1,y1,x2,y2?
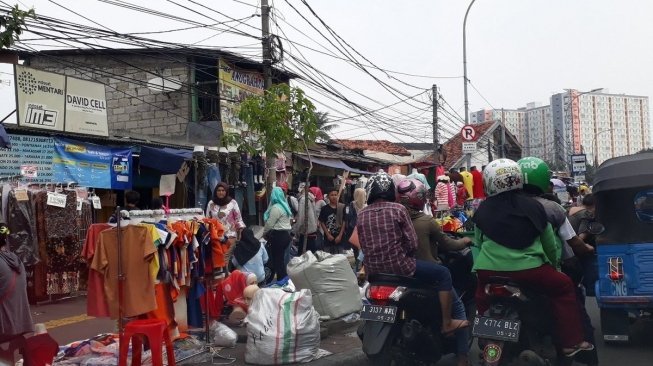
0,134,54,183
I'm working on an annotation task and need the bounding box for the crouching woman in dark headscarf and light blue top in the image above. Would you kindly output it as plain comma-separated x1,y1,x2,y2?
231,228,268,284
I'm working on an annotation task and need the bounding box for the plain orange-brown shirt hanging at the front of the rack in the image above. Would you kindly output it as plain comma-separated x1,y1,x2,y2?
91,225,156,318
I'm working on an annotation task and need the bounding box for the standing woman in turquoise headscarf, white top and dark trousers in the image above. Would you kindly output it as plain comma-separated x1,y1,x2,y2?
263,187,292,280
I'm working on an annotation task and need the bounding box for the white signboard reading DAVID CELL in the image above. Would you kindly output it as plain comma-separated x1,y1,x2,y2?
65,77,109,136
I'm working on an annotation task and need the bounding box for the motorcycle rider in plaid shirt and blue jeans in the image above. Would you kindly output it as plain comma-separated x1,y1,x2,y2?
356,172,469,334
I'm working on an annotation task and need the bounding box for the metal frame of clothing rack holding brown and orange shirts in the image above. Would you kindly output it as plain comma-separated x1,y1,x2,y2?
115,207,236,365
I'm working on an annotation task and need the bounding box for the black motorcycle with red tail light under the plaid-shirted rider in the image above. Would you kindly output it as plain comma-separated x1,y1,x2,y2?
358,244,476,365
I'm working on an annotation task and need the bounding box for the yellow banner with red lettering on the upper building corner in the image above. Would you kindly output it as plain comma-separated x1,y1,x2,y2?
218,59,264,133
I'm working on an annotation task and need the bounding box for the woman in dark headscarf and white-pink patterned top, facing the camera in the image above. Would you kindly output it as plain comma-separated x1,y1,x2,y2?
206,182,245,247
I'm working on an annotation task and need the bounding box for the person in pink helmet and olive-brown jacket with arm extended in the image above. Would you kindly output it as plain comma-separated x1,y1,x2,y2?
397,179,472,366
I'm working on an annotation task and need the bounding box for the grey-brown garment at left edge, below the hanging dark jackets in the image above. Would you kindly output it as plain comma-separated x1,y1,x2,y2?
0,248,32,336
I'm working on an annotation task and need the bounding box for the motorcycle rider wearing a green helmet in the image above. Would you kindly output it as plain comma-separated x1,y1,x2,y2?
517,157,598,365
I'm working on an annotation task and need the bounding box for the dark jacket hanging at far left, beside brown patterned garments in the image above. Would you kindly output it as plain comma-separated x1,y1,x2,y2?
3,186,39,266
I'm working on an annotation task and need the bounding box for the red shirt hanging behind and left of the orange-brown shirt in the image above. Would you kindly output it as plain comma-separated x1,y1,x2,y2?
82,224,111,317
